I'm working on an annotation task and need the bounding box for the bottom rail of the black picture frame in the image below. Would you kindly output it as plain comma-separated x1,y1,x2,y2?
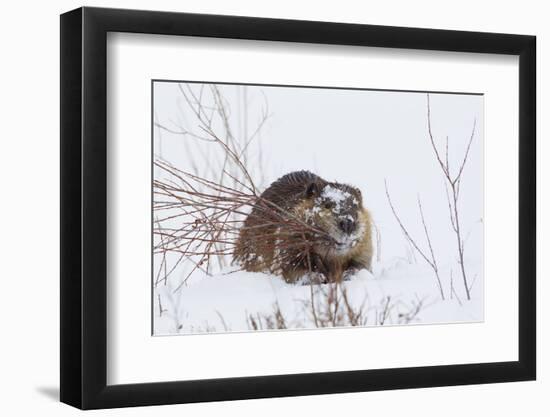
86,362,534,409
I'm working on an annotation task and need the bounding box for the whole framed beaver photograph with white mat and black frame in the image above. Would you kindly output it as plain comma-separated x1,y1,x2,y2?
61,7,536,409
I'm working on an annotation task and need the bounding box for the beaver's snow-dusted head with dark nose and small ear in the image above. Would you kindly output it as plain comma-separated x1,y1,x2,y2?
304,182,365,256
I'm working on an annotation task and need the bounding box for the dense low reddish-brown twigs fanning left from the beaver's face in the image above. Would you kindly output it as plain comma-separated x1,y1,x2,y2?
153,151,336,291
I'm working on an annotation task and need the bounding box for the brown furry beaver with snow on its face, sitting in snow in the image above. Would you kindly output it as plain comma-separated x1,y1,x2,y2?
233,171,373,283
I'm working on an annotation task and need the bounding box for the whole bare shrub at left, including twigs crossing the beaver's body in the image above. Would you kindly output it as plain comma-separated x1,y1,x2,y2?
153,85,352,291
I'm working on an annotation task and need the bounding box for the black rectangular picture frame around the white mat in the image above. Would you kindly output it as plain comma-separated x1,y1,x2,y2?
60,7,536,409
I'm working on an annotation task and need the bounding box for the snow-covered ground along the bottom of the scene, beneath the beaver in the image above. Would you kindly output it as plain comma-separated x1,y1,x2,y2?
153,259,483,335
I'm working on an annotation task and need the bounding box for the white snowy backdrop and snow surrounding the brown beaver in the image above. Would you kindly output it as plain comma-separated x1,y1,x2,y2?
153,82,484,335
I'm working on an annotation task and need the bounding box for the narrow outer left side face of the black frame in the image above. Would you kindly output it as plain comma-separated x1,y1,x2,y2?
60,9,83,408
